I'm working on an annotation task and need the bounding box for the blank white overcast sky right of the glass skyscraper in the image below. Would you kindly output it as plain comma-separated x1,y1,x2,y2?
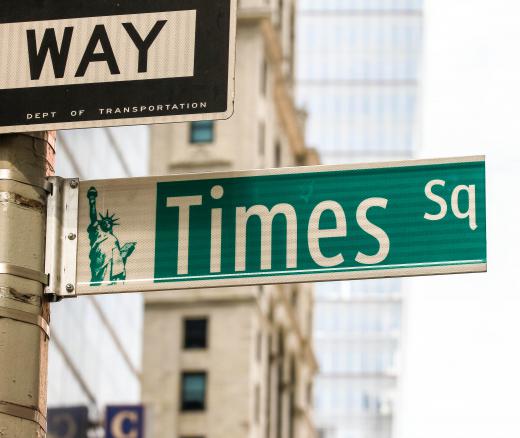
396,0,520,438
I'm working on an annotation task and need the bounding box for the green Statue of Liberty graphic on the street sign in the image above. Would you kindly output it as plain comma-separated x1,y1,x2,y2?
87,187,137,286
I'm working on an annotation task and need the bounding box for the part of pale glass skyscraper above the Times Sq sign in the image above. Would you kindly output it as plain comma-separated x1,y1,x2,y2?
297,0,422,163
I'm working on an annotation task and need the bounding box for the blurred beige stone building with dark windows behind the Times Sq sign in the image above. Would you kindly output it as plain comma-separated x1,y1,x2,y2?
143,0,317,438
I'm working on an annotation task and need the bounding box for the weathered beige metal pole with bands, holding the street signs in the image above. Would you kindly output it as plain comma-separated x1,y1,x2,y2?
0,132,56,438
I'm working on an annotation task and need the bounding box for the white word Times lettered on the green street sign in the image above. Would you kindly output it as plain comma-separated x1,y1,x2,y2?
166,185,394,275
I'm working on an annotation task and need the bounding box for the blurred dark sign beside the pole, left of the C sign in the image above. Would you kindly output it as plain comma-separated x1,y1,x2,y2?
47,406,88,438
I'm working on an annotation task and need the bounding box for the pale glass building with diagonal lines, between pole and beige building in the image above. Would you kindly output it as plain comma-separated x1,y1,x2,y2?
48,126,149,438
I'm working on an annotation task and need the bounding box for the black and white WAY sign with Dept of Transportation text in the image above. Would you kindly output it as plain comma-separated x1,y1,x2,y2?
0,0,236,133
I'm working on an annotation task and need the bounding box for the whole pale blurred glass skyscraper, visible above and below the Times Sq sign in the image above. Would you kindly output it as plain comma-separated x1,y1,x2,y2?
296,0,423,438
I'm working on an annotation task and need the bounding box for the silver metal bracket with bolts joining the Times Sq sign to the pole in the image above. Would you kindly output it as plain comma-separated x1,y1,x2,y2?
45,177,79,300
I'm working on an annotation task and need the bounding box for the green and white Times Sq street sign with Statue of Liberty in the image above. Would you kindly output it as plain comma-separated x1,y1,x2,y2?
45,157,486,296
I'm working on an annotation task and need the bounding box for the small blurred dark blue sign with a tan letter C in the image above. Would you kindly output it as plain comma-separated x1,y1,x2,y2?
105,405,144,438
